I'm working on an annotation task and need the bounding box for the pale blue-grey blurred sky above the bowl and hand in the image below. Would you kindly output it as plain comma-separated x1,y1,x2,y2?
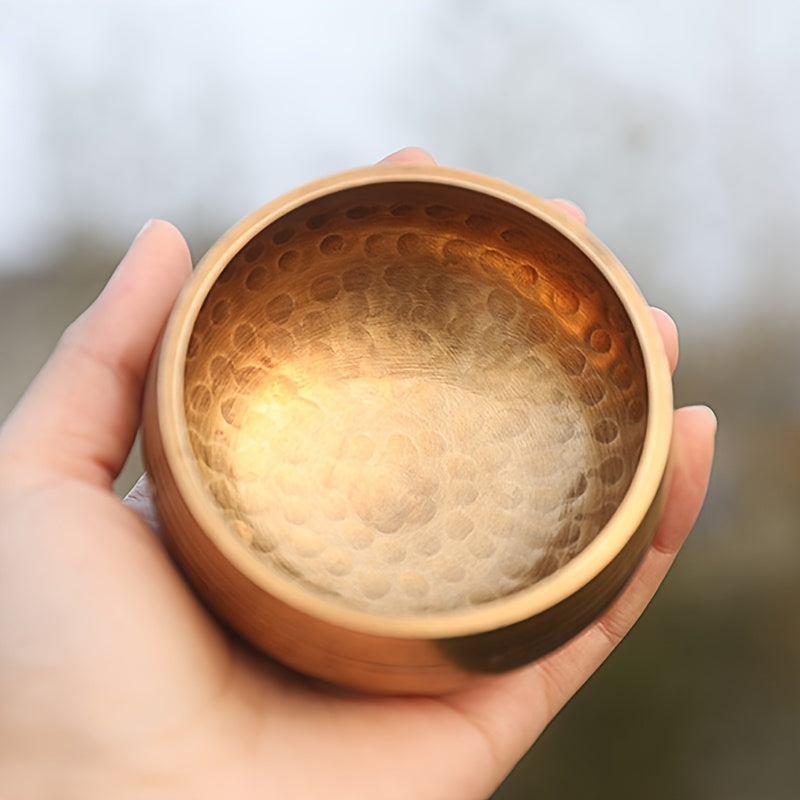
0,0,800,328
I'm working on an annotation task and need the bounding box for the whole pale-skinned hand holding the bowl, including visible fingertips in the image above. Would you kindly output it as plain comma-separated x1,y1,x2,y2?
0,148,716,800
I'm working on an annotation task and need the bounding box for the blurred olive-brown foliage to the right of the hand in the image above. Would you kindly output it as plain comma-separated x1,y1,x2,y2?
495,322,800,800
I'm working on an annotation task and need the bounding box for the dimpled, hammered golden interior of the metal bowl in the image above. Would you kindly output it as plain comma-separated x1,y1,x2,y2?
184,182,647,615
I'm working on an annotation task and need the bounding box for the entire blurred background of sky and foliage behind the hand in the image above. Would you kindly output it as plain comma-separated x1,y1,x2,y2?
0,0,800,800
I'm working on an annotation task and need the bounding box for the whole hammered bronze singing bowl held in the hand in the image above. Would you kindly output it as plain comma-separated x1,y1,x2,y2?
143,165,672,693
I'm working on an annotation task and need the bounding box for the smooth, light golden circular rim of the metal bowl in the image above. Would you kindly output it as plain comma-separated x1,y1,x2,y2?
154,164,673,639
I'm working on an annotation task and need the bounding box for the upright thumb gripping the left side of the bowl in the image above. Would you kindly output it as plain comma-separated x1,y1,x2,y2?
0,221,191,485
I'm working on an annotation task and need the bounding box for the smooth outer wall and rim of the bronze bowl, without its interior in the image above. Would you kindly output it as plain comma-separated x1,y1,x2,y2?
143,166,672,682
